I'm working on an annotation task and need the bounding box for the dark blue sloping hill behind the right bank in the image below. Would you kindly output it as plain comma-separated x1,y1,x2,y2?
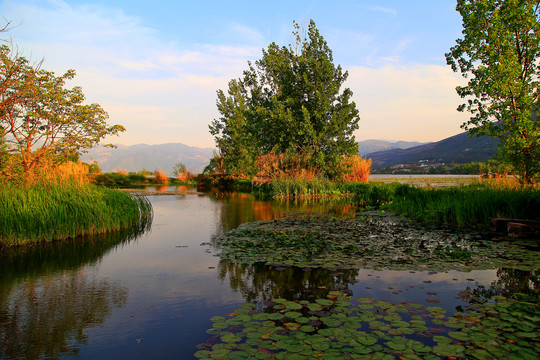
365,132,498,169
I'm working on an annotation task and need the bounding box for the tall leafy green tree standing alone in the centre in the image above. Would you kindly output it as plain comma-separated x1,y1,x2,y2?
210,21,359,177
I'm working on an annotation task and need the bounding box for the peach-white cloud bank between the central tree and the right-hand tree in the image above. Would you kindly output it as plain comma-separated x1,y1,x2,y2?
346,64,468,141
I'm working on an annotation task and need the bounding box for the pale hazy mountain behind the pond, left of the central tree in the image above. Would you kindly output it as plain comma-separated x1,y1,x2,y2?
81,143,213,174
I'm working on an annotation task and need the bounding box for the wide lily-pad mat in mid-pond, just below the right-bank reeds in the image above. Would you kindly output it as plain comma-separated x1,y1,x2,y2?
215,215,540,271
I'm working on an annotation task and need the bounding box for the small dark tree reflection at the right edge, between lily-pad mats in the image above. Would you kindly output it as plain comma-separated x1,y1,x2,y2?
461,268,540,303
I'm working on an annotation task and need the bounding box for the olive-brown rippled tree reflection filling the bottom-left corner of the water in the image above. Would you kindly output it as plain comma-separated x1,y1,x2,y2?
0,268,128,359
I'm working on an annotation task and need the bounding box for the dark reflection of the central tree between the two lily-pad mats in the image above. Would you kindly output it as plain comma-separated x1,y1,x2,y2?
218,260,358,304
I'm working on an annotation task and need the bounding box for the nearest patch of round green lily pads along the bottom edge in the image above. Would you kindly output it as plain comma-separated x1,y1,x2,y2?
195,291,540,359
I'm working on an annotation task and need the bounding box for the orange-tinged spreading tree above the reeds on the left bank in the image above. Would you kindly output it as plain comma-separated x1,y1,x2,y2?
0,45,125,173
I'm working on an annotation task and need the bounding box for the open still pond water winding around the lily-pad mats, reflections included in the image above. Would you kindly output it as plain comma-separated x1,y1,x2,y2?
0,189,510,359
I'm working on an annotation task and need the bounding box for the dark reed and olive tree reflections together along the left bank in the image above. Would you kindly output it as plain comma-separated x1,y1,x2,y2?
0,218,152,359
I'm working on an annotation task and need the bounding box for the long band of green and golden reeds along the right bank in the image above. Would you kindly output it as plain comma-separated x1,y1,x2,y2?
122,175,540,229
